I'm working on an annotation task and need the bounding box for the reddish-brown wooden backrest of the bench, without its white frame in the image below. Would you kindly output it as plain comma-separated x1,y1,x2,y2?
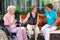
20,13,60,30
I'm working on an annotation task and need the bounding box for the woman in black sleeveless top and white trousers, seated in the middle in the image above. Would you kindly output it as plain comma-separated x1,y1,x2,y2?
23,6,39,40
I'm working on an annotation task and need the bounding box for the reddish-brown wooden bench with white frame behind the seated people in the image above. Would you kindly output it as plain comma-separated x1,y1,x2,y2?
20,13,60,34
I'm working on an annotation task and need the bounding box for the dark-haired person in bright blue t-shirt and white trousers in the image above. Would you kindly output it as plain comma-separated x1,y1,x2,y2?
40,4,58,40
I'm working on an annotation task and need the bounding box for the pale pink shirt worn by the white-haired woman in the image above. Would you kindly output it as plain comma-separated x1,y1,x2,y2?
4,13,15,27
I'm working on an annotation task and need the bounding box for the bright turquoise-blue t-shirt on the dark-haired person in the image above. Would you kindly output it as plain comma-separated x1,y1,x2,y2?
44,10,58,25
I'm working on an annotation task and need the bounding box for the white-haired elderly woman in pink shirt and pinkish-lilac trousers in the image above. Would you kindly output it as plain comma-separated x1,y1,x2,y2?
4,6,28,40
